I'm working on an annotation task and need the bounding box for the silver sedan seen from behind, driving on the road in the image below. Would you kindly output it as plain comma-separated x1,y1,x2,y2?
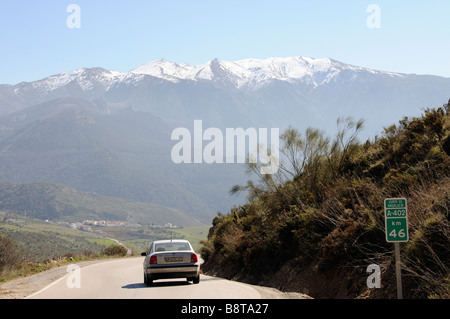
141,239,200,286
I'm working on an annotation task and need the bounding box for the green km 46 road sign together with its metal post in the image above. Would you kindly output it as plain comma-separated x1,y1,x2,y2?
384,198,409,299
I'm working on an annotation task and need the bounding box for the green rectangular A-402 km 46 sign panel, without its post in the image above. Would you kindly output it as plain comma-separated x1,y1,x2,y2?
384,198,408,242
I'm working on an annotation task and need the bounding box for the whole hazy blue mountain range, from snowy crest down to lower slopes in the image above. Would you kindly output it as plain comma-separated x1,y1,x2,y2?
0,57,450,223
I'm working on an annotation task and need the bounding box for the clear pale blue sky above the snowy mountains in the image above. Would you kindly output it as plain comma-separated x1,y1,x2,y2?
0,0,450,84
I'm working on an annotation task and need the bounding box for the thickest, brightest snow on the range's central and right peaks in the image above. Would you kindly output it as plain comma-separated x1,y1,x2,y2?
130,57,401,88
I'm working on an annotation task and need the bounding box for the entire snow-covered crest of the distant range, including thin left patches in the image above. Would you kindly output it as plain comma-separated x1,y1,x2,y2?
9,57,403,95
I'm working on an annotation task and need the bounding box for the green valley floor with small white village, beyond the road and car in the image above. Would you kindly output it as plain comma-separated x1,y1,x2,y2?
0,211,209,262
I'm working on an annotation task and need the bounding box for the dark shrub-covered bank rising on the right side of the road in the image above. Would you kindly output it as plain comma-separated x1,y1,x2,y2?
201,101,450,298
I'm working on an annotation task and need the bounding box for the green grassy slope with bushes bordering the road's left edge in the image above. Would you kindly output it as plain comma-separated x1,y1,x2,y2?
0,216,122,282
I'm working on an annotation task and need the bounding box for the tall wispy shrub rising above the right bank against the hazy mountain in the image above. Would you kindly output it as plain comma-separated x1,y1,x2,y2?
230,117,363,201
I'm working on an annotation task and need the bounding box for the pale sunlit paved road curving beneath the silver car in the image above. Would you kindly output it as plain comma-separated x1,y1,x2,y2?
28,257,307,299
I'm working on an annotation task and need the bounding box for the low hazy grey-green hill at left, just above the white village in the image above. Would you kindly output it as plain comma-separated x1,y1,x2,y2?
0,182,201,226
